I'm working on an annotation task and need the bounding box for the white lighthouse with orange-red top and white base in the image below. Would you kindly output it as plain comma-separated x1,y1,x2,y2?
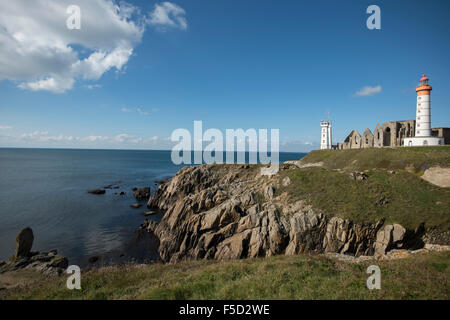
404,75,444,147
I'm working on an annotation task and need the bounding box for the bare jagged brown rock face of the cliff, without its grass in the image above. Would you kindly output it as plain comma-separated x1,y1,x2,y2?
142,164,440,263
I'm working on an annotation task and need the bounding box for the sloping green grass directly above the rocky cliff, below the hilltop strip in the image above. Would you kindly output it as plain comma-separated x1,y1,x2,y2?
277,168,450,230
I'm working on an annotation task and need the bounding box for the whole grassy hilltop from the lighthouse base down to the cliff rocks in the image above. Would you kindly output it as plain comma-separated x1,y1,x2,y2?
277,146,450,230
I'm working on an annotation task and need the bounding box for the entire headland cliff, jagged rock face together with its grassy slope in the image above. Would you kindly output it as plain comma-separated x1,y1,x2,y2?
143,149,450,263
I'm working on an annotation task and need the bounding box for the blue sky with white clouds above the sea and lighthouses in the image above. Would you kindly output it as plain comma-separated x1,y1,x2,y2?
0,0,450,152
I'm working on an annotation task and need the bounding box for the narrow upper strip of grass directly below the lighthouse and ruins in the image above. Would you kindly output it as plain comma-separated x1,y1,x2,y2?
302,146,450,172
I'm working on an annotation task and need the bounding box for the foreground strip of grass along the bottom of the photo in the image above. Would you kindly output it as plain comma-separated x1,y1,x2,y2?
0,252,450,299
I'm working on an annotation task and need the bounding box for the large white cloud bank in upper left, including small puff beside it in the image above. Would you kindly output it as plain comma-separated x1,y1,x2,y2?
0,0,187,93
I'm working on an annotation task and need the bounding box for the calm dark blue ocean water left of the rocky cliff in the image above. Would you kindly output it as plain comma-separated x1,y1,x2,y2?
0,148,305,266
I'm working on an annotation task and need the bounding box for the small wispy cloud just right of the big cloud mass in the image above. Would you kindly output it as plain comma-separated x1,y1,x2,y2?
148,2,187,30
